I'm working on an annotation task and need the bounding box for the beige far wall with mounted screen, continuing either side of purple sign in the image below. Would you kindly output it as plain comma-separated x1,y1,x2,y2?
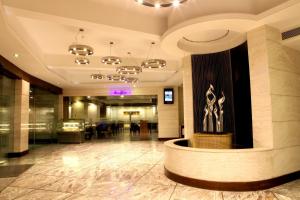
63,86,179,138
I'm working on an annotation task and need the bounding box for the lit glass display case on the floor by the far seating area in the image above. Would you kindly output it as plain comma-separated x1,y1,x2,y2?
57,119,85,143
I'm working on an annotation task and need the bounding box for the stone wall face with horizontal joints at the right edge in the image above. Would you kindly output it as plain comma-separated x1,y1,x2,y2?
266,28,300,153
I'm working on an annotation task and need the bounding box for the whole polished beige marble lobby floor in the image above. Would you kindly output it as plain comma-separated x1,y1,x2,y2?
0,140,300,200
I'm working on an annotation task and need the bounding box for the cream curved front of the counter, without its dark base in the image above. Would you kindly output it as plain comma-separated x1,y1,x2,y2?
164,144,273,182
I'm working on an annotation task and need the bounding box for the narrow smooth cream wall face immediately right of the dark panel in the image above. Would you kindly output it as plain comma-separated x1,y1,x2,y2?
247,27,273,147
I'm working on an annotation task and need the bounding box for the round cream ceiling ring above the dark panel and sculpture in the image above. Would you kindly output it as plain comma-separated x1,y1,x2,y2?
161,13,258,57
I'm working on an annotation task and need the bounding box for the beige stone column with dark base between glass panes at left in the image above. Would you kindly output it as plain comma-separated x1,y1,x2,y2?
11,80,30,156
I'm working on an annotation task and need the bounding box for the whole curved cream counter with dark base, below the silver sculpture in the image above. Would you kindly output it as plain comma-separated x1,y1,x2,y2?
164,139,299,191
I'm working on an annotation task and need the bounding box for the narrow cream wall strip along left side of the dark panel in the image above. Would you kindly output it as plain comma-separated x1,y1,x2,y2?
183,55,194,138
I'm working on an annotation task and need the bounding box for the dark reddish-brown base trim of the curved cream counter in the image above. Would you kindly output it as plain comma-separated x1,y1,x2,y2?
165,168,300,191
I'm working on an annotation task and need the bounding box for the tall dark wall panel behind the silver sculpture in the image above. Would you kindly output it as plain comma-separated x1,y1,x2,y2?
192,43,253,148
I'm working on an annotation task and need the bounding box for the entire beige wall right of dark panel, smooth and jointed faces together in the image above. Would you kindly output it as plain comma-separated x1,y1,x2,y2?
248,26,300,177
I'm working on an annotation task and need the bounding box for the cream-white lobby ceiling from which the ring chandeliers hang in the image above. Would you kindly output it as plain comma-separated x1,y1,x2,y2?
0,0,300,88
